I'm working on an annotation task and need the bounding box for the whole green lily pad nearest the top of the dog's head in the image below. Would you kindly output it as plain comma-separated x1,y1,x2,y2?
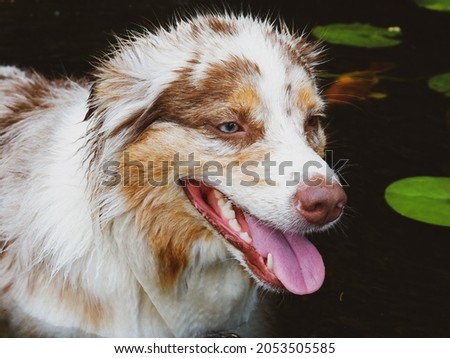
312,23,401,48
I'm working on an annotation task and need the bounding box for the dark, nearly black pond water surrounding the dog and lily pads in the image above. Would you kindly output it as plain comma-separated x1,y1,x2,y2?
0,0,450,337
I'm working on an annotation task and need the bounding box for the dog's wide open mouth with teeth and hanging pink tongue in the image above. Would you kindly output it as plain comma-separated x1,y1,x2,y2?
184,179,325,295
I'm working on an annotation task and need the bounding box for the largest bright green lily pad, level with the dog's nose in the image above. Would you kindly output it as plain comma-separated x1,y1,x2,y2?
384,177,450,226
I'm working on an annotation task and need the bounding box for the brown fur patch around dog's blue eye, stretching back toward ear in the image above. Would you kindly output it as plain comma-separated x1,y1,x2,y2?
121,58,264,146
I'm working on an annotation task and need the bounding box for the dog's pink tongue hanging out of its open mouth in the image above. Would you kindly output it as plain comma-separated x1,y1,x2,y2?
245,214,325,295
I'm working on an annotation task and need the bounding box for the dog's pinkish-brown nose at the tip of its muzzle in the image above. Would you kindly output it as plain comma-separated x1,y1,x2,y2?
296,176,347,225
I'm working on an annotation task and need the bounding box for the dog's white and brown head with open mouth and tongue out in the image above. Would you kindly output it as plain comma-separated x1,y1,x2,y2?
91,16,346,304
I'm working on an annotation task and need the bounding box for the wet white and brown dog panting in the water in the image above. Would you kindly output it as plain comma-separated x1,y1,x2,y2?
0,14,347,337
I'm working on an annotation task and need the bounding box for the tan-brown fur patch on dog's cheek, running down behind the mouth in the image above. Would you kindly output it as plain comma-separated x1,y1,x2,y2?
120,136,212,289
